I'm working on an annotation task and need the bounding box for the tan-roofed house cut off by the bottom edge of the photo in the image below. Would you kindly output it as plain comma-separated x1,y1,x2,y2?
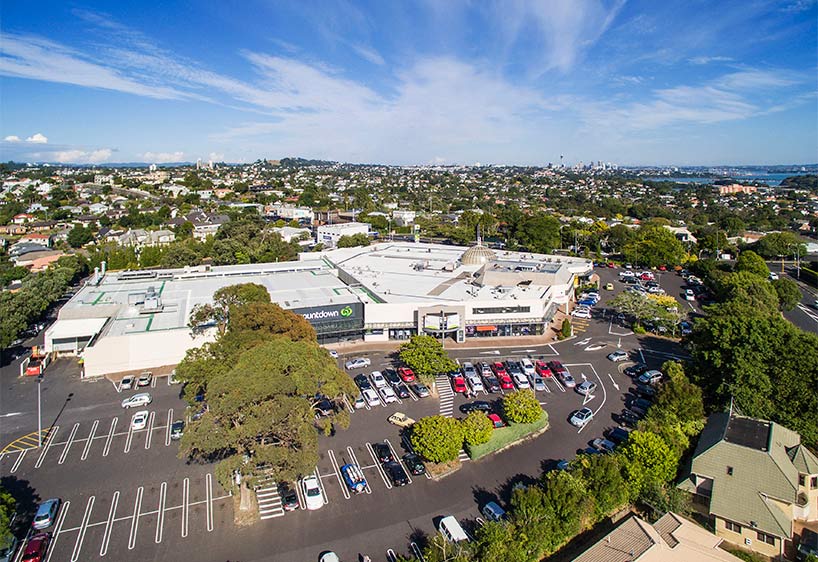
573,513,740,562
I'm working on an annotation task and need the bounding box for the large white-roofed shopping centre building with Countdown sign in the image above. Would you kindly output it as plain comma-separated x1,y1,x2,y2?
45,242,592,376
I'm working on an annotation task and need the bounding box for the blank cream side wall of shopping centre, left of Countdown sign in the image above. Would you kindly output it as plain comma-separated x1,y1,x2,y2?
82,328,215,377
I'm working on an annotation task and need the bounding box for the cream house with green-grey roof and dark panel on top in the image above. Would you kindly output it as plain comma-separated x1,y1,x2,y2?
679,413,818,558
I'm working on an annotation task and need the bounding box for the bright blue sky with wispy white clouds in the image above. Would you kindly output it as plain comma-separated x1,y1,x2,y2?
0,0,818,165
